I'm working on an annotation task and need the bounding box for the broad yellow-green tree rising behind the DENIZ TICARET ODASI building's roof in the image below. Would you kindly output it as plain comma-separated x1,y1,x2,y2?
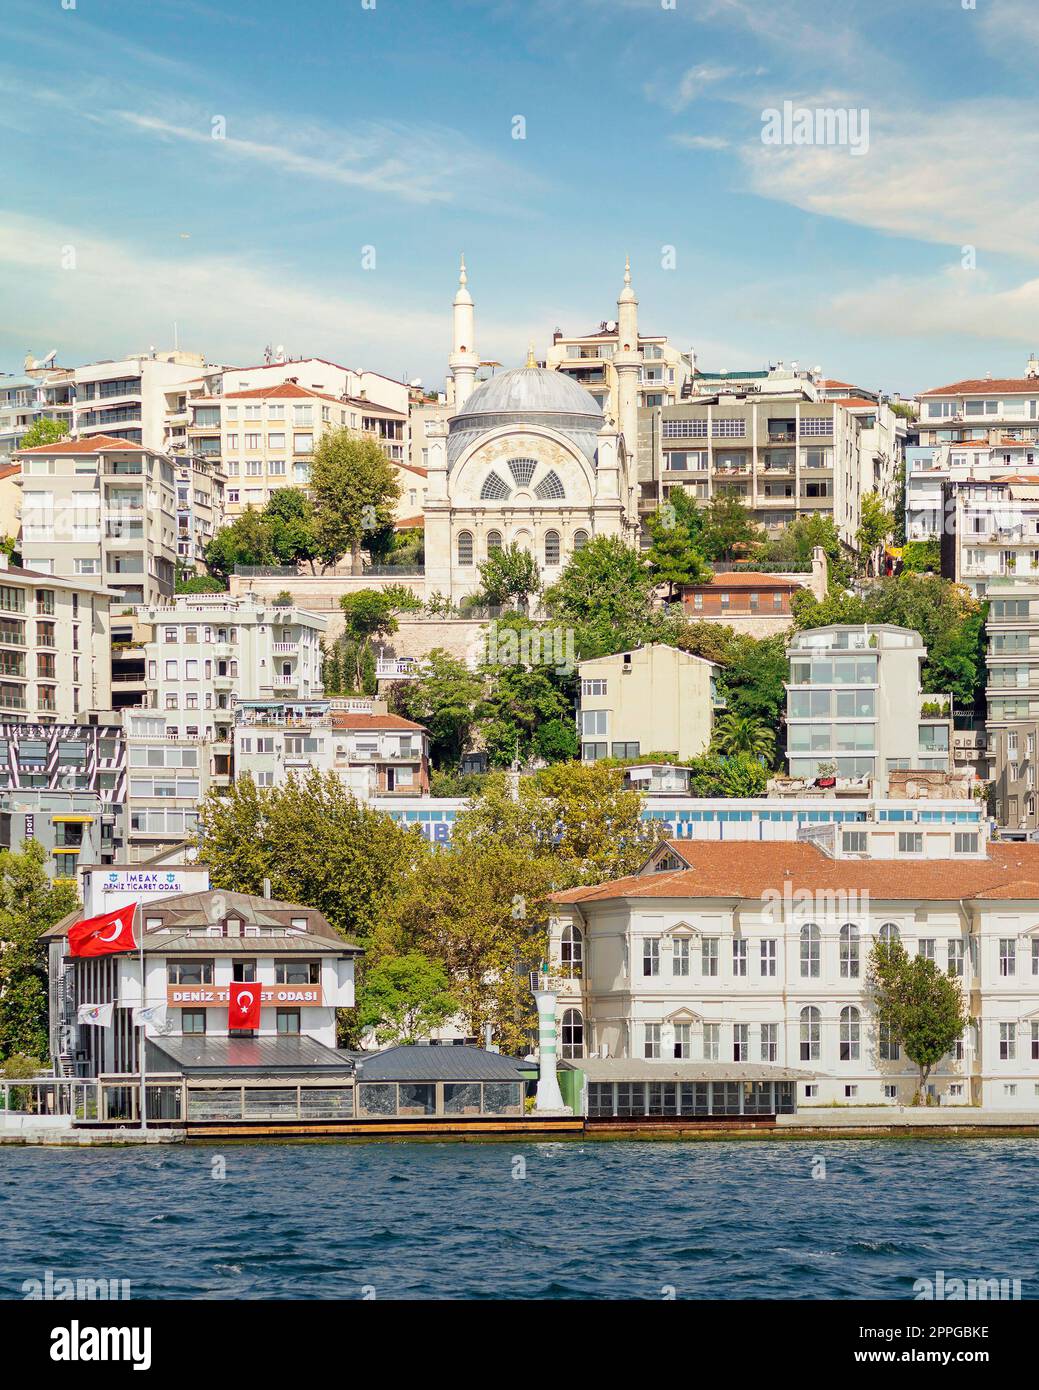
199,769,428,941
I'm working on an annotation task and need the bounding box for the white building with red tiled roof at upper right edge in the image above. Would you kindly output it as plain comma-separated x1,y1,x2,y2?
919,356,1039,446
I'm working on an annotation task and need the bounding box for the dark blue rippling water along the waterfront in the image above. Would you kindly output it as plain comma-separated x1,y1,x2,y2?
0,1140,1039,1298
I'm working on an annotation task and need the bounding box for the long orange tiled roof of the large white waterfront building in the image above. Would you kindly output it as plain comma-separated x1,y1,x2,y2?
552,826,1039,904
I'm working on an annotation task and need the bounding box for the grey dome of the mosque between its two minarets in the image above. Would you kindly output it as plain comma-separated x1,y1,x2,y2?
448,367,602,470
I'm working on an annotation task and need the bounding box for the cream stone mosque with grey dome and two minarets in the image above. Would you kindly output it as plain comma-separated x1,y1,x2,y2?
424,260,641,602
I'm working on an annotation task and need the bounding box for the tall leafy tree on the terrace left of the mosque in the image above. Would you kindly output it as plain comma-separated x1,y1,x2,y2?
310,428,401,574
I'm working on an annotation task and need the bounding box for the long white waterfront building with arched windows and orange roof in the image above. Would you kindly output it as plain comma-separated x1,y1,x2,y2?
549,842,1039,1115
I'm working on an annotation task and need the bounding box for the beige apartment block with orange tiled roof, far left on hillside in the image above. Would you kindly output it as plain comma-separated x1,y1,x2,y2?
15,435,177,603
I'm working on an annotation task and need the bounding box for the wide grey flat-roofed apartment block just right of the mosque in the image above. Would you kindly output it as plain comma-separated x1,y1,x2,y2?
638,378,901,549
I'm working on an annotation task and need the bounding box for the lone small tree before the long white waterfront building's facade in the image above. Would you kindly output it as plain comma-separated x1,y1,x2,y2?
868,941,969,1102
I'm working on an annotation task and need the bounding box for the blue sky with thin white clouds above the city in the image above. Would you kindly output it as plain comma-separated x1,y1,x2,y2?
0,0,1039,395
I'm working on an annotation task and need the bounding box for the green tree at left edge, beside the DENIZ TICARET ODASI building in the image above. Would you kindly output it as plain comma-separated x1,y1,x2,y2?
0,840,79,1061
